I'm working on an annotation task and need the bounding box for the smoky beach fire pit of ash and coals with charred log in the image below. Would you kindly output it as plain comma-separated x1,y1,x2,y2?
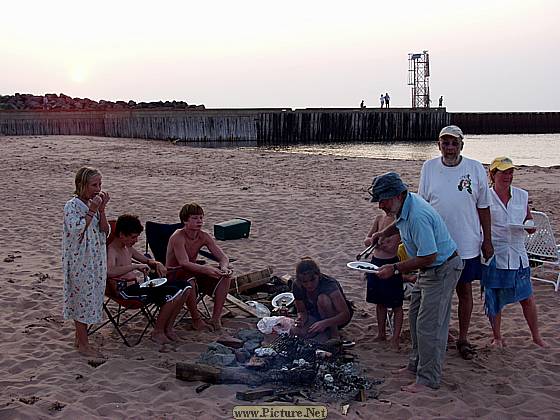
176,334,382,402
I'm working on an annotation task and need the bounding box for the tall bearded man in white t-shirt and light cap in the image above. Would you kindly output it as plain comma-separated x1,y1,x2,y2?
418,125,494,359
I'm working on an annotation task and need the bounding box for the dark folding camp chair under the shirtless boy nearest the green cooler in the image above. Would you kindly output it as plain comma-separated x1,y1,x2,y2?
146,221,234,318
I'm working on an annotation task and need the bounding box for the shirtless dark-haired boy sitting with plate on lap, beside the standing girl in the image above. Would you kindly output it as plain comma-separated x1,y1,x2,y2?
107,214,192,344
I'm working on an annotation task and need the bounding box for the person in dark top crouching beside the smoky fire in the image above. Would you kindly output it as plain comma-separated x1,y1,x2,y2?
290,257,354,341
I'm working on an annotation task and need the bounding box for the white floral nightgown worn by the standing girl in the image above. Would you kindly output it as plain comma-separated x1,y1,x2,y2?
62,197,107,324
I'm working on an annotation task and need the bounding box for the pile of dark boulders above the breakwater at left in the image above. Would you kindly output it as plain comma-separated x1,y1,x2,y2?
0,93,205,111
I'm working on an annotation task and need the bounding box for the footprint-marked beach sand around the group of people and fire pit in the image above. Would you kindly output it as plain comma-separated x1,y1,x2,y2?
0,136,560,419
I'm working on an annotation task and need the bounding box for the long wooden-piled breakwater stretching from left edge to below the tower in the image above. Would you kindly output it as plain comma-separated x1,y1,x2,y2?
0,108,449,145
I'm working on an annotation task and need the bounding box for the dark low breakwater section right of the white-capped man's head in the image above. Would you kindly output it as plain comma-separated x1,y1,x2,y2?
449,112,560,134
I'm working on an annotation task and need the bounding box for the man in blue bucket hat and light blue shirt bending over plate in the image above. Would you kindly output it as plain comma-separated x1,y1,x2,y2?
369,172,463,392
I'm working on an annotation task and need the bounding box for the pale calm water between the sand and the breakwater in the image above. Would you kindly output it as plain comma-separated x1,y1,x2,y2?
266,134,560,167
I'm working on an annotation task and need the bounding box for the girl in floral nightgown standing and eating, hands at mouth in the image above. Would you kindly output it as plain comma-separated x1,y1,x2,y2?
62,167,109,357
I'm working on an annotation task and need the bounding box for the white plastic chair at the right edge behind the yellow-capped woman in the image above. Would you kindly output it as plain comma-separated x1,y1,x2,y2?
525,211,560,292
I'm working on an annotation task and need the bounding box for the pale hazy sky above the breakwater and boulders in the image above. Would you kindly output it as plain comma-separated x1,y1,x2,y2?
0,0,560,112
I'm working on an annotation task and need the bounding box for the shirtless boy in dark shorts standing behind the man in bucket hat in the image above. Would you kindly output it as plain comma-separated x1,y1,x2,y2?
364,215,404,350
